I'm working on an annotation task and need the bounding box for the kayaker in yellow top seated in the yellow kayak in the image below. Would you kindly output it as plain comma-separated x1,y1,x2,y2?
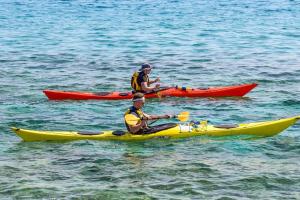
124,92,173,134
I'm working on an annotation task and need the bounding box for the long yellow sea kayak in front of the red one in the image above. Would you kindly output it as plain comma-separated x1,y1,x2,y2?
12,116,300,141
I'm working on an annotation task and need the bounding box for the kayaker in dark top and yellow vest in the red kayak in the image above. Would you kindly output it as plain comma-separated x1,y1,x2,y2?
131,63,160,93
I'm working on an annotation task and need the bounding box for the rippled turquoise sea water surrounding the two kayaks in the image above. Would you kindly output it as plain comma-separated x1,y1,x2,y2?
0,0,300,200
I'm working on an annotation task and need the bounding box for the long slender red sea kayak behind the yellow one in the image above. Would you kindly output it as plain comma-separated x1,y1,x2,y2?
43,83,257,100
